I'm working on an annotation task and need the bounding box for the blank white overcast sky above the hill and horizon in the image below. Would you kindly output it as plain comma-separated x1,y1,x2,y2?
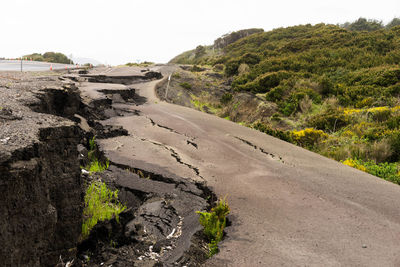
0,0,400,65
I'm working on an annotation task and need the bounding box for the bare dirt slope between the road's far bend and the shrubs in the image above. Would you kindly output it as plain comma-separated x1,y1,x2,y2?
156,66,278,123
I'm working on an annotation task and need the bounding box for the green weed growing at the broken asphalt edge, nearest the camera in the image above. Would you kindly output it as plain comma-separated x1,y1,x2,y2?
196,197,230,257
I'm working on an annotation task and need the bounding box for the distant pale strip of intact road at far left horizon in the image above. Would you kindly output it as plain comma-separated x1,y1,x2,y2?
0,60,75,71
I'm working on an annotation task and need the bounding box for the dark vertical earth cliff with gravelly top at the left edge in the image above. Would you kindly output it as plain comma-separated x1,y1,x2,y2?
0,74,83,266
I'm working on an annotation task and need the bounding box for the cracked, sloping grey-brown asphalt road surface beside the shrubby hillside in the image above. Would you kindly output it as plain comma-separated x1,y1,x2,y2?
86,67,400,266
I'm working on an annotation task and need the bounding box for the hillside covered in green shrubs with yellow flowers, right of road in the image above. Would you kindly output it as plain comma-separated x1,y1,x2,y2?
166,18,400,183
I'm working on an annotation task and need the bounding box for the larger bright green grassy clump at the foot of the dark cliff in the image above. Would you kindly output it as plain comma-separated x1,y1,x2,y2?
82,181,126,239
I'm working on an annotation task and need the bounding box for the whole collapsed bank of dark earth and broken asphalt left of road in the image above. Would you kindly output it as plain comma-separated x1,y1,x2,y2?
0,69,215,266
